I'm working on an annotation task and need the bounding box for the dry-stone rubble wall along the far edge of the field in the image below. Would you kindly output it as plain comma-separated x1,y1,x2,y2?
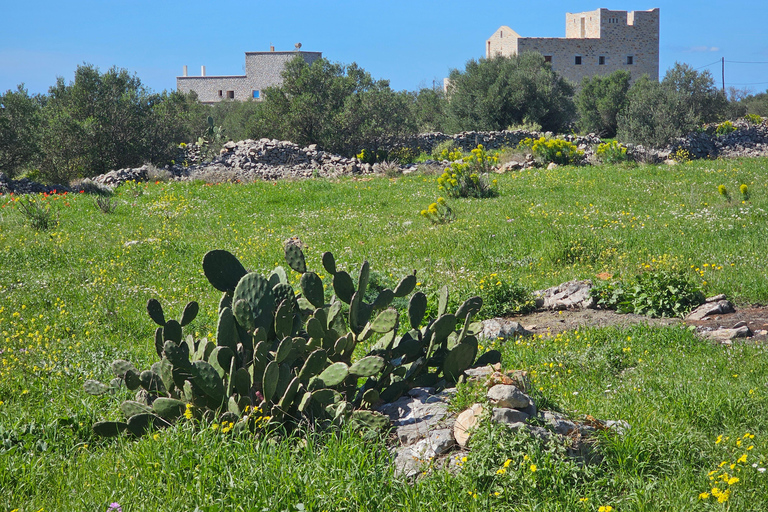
0,119,768,194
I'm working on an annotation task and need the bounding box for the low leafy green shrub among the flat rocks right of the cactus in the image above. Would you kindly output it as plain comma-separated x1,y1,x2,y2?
590,270,704,317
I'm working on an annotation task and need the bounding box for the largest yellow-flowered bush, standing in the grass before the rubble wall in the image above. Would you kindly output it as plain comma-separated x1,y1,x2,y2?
437,144,498,198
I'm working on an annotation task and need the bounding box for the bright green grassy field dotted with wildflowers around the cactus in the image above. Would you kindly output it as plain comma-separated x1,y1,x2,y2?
0,159,768,512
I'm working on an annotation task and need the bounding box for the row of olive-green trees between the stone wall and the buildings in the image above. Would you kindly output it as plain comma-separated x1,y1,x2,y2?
0,53,768,183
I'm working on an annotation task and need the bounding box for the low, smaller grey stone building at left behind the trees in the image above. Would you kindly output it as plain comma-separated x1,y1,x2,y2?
176,45,323,103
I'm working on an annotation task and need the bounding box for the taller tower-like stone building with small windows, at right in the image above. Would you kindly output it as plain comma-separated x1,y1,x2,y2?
485,9,659,84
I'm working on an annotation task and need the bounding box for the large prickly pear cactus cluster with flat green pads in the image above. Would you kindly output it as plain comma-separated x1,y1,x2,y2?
84,242,498,436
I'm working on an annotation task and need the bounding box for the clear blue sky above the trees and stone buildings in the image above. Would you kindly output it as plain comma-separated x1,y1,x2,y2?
0,0,768,93
